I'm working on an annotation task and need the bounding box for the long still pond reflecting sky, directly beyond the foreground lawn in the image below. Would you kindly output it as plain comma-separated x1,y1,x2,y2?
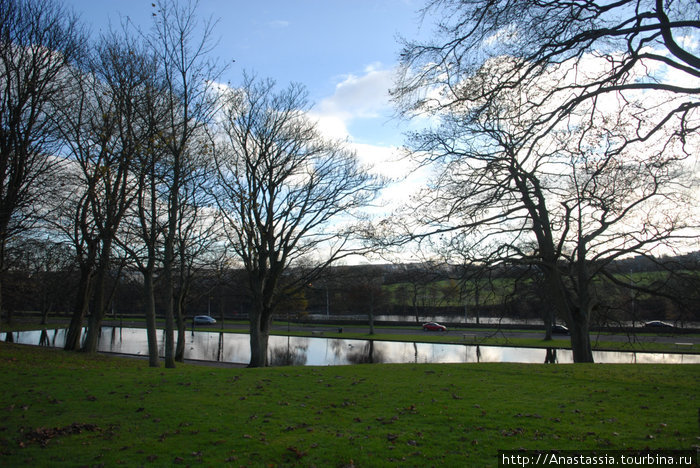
5,327,700,366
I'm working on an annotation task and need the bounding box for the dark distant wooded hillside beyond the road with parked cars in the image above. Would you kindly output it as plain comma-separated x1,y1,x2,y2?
3,239,700,325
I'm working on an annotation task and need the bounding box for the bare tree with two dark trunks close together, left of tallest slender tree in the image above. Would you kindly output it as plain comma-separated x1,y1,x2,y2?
61,34,154,352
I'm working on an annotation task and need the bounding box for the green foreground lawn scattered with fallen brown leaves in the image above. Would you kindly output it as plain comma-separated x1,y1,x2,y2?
0,343,700,467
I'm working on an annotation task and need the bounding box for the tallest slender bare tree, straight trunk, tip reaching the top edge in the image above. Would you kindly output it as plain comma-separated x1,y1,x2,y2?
148,0,221,367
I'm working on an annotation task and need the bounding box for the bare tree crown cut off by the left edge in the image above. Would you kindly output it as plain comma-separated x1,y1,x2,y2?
0,0,82,328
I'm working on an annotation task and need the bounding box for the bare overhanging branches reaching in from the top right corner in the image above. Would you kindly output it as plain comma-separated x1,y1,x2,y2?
394,0,700,140
